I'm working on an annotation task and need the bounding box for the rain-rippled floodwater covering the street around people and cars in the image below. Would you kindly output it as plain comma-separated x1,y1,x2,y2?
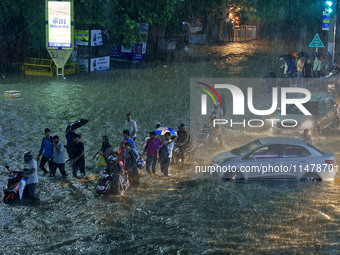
0,42,340,254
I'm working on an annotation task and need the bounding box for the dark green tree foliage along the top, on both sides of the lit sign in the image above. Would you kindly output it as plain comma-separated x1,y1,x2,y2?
0,0,330,57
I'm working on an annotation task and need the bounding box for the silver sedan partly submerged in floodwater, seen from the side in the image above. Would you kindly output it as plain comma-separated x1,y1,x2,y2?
209,137,337,181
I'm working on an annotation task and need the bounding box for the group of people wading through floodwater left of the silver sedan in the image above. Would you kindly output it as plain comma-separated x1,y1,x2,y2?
20,113,188,199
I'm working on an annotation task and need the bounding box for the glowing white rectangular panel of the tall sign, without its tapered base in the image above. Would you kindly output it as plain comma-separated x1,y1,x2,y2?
47,1,72,48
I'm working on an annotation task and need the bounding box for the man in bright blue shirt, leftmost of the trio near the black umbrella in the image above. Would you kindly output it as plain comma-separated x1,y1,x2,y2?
37,128,53,176
